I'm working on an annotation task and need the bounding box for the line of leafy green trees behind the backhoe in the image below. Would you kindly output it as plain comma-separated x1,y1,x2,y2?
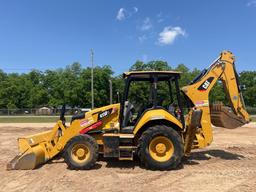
0,61,256,109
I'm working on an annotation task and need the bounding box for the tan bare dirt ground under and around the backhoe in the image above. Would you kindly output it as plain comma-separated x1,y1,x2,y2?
0,123,256,192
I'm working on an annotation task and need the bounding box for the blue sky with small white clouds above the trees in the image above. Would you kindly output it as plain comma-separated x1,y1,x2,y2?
0,0,256,75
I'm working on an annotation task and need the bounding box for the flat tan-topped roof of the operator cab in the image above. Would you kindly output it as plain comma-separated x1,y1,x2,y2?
123,71,182,80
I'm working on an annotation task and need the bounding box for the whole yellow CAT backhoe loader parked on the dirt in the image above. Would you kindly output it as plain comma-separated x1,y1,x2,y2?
7,51,250,170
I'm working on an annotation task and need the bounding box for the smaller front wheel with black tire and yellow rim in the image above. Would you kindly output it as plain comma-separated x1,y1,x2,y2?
63,135,99,170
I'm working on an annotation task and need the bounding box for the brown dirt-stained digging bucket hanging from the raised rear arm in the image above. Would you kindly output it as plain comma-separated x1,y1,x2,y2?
210,104,247,129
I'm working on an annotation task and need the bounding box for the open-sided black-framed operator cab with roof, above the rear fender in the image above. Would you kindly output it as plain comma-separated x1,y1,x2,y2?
120,71,184,133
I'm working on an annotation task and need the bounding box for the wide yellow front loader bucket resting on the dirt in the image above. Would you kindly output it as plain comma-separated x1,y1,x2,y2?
7,131,52,170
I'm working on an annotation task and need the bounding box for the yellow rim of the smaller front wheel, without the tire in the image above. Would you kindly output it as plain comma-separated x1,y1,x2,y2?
71,144,91,164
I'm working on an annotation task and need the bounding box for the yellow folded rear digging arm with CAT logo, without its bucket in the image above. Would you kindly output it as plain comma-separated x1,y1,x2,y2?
181,51,250,148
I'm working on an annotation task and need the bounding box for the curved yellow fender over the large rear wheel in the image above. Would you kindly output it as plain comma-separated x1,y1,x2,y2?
133,109,183,135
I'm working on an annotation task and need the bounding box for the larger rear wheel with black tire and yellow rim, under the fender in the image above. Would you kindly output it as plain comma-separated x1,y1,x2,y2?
138,125,184,170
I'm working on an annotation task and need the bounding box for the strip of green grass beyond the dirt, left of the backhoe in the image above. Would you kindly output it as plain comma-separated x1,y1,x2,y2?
0,116,71,123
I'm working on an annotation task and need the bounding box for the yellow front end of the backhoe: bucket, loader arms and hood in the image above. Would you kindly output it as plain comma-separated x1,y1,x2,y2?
7,104,120,170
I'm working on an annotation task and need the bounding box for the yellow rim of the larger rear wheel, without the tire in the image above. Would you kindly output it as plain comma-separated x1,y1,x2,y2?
149,136,174,162
